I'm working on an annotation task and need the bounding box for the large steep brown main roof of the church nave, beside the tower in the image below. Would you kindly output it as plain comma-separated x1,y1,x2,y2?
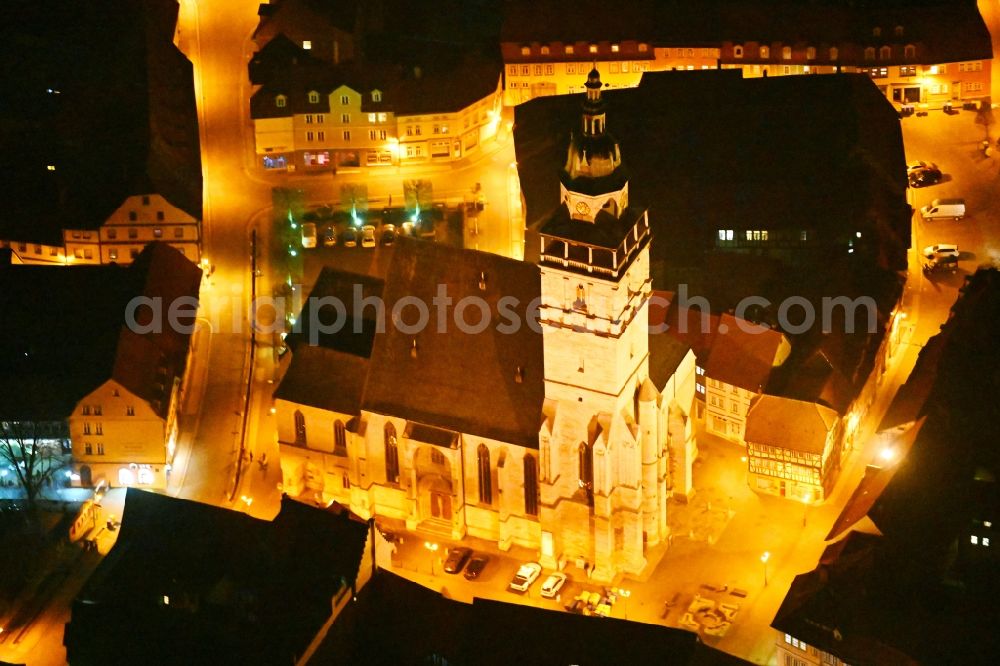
362,238,545,448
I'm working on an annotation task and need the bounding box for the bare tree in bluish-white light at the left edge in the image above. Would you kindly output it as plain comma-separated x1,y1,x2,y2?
0,421,66,510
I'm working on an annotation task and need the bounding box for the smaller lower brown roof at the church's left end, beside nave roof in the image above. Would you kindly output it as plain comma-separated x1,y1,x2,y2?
274,344,368,415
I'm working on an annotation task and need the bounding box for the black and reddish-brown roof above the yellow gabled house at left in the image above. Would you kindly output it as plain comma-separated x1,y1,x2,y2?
0,243,201,419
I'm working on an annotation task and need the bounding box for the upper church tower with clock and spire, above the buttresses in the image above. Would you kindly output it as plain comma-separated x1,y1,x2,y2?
539,69,651,418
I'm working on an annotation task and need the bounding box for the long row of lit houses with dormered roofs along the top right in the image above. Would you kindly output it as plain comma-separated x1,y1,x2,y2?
501,2,992,107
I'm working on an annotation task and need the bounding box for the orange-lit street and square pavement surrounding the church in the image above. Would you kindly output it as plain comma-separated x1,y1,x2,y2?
0,0,1000,665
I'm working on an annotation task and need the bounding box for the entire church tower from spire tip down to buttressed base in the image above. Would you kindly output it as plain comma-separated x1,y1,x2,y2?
539,69,663,580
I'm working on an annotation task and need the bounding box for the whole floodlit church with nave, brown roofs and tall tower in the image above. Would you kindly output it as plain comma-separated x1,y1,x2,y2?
274,70,695,581
